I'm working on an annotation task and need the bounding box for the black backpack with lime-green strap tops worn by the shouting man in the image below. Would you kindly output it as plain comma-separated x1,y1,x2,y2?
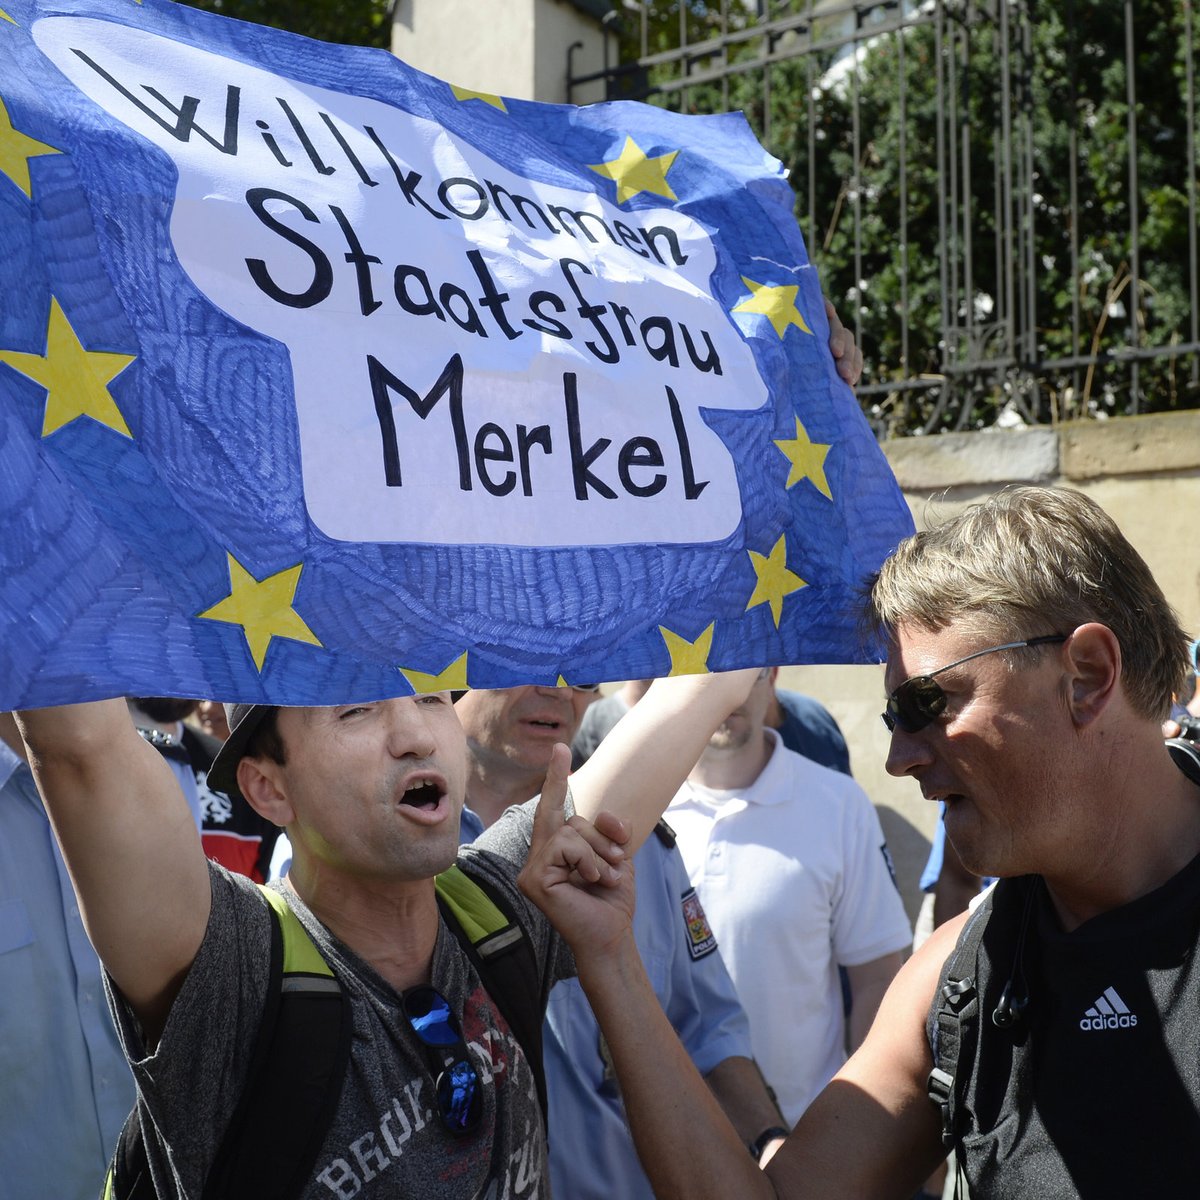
101,866,546,1200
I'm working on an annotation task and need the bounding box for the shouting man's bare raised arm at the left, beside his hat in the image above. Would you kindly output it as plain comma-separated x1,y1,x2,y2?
17,700,211,1044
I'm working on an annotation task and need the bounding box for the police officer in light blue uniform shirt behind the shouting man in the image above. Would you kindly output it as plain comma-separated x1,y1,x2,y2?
456,682,786,1200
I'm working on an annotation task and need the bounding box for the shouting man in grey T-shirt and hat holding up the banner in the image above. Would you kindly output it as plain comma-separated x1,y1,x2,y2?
18,676,748,1200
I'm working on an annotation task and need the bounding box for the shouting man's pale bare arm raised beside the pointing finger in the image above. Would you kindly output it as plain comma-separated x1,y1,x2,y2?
571,670,758,854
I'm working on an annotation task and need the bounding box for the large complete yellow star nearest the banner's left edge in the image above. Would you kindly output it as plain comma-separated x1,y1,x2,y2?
0,296,137,438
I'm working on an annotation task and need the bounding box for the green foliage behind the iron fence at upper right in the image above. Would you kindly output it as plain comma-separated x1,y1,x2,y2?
626,0,1200,433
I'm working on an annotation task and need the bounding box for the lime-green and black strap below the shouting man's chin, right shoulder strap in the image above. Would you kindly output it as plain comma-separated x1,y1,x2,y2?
434,865,547,1120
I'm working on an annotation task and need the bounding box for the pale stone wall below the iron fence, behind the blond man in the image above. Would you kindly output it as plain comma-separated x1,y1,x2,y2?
781,413,1200,914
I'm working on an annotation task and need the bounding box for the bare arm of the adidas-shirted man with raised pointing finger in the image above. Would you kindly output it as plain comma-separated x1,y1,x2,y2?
521,777,960,1200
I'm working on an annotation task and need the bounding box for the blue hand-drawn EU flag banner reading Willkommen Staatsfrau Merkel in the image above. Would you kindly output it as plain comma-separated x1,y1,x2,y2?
0,0,911,708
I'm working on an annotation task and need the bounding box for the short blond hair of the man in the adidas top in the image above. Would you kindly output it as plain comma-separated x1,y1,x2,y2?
864,487,1188,720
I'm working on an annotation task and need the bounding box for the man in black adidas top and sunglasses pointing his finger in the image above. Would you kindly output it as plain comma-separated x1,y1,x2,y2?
521,487,1200,1200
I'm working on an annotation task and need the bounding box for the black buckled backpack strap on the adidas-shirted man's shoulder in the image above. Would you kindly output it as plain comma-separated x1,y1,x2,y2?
925,881,1003,1148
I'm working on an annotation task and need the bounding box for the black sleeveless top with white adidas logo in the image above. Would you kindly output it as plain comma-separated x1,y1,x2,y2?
945,857,1200,1200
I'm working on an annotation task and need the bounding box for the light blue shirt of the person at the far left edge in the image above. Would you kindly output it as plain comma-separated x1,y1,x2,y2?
0,742,133,1200
